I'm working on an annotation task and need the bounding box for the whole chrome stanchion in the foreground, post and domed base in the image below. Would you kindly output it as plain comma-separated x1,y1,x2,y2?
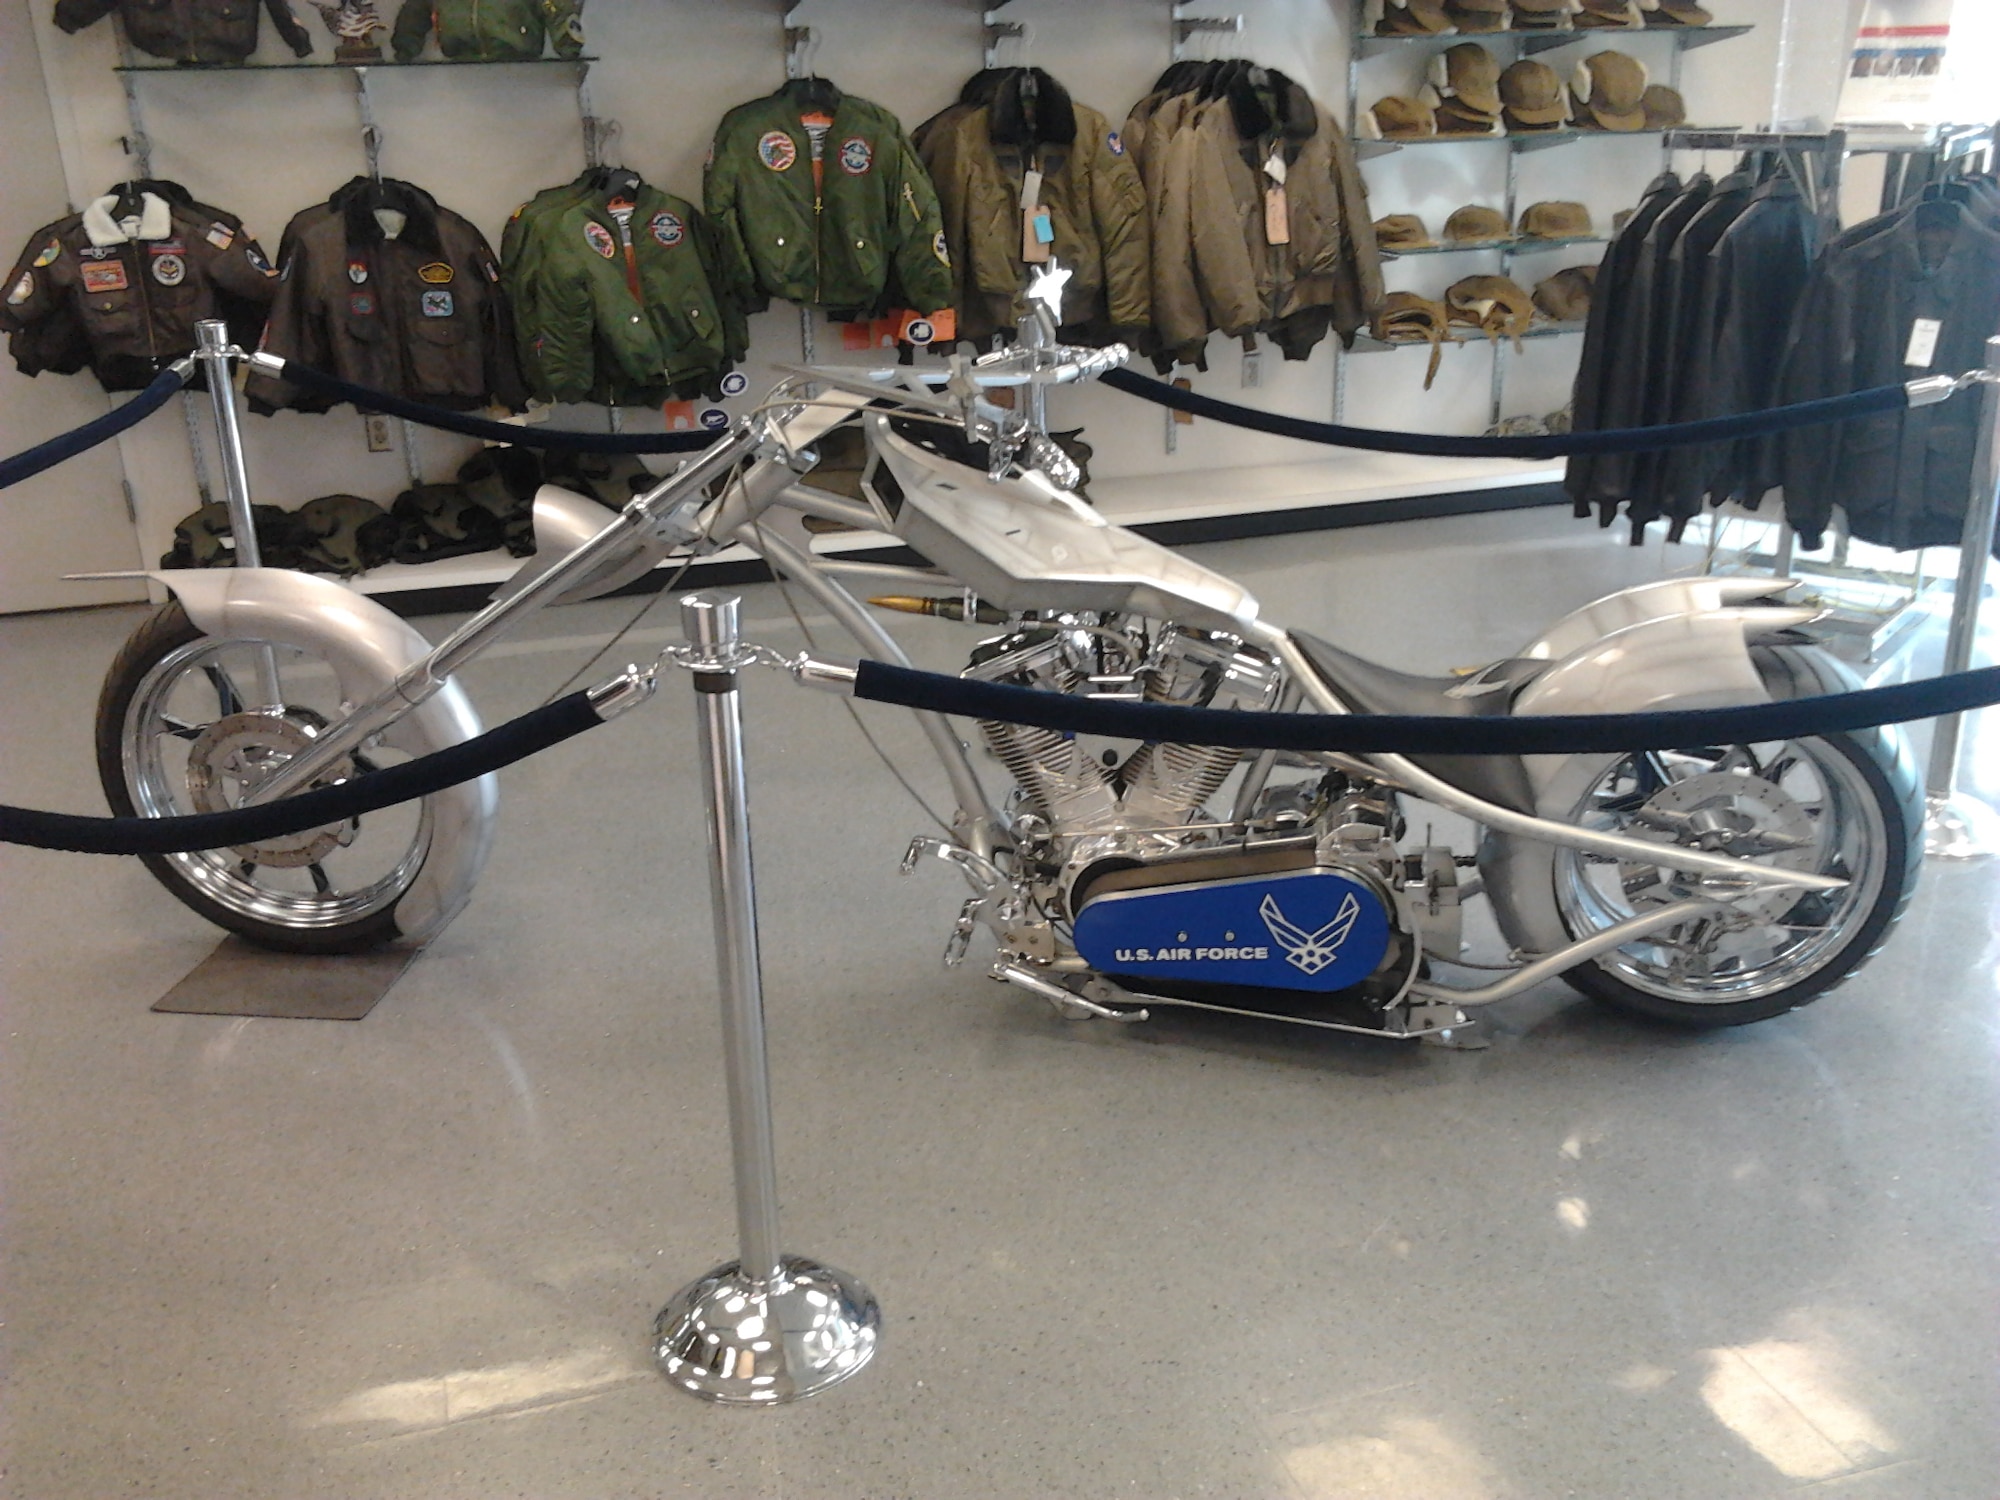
652,594,882,1406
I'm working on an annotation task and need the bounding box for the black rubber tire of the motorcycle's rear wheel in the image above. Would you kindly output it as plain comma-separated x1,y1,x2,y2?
1556,650,1924,1028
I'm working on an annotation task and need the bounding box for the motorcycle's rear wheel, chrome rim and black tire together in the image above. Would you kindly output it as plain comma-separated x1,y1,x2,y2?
1554,730,1922,1028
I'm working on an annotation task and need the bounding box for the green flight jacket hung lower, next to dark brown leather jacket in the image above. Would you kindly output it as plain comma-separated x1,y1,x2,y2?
502,174,748,404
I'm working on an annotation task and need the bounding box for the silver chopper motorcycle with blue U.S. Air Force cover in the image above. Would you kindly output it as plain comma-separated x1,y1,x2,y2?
96,288,1922,1040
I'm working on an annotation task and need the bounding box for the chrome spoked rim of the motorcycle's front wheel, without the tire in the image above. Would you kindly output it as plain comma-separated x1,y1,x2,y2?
122,636,432,928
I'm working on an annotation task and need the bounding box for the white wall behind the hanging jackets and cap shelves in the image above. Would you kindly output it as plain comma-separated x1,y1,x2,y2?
0,0,1808,608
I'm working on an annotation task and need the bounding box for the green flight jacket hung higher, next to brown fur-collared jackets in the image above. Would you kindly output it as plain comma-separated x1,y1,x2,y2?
702,78,952,316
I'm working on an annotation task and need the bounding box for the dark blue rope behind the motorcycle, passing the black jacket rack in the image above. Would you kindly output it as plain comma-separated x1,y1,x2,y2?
1102,370,1910,458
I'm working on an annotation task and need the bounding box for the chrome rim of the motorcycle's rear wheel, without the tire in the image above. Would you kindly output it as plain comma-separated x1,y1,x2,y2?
1556,740,1888,1006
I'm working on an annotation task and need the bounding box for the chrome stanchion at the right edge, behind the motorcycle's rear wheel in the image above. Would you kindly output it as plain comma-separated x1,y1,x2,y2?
1924,338,2000,860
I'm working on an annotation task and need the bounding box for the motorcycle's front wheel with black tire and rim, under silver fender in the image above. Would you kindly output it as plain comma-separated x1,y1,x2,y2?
96,604,440,954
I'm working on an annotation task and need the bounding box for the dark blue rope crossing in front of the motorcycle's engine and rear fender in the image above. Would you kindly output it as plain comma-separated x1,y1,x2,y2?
854,662,2000,756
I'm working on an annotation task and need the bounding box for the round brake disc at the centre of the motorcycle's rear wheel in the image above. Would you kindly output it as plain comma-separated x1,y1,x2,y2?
1618,770,1818,922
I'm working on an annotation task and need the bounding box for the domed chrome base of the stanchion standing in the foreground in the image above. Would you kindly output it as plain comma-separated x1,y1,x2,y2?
652,1256,882,1406
